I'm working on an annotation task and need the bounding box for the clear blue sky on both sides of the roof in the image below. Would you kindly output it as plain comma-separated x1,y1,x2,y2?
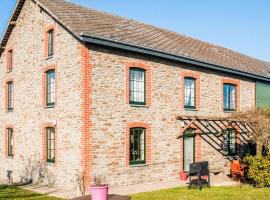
0,0,270,61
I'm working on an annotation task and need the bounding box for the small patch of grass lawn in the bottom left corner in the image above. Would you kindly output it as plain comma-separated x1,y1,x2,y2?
0,185,60,200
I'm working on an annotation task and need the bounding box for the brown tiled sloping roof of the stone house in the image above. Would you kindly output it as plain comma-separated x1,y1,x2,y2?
1,0,270,78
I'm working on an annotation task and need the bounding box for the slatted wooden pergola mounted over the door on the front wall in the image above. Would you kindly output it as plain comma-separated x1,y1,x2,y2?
176,116,255,139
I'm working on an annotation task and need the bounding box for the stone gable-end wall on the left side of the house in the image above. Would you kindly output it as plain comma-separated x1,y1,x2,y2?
0,0,82,188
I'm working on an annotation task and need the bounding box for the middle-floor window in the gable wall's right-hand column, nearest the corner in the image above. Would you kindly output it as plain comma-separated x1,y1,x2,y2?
46,69,55,107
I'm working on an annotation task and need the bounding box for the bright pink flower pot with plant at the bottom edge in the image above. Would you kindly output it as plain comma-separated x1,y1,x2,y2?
90,175,109,200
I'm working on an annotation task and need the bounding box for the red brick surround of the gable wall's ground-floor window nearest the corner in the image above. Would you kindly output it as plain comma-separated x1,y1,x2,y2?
42,122,58,164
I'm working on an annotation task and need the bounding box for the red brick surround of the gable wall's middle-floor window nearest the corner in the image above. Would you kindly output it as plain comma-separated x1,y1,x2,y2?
42,65,57,108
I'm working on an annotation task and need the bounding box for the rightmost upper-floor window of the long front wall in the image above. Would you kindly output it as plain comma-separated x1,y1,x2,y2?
223,83,236,111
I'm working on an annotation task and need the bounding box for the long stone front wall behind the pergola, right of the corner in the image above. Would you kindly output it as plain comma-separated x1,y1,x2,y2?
89,46,255,186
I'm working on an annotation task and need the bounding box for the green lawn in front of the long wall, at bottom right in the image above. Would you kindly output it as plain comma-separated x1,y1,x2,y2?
132,186,270,200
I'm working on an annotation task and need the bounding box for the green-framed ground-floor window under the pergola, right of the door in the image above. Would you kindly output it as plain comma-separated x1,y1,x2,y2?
223,129,237,156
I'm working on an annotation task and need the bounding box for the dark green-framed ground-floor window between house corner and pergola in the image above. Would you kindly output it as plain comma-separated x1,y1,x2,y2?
129,128,146,165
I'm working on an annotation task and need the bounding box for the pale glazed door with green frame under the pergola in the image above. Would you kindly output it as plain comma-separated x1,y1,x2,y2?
183,131,195,171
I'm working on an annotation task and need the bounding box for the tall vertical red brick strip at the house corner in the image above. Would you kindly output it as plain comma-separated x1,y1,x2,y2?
80,45,92,188
